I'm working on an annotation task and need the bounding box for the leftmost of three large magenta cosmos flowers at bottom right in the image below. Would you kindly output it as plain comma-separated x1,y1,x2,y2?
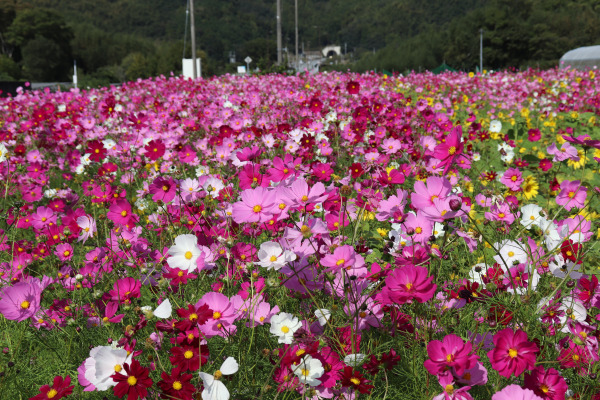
424,335,479,376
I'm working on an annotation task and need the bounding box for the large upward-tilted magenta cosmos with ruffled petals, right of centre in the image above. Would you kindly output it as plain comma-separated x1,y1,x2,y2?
380,265,437,304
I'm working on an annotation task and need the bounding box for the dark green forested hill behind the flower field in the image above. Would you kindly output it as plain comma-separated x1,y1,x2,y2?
0,0,600,83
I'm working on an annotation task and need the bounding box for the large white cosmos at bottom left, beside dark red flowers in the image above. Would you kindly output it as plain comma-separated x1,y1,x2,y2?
84,346,133,391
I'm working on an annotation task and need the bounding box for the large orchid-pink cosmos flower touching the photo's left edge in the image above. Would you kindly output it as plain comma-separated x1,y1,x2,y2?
0,282,42,321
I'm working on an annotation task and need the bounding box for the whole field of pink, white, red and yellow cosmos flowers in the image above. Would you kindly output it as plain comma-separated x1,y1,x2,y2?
0,69,600,400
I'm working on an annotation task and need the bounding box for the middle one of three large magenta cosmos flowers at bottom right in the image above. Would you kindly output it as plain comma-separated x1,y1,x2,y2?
488,328,539,378
